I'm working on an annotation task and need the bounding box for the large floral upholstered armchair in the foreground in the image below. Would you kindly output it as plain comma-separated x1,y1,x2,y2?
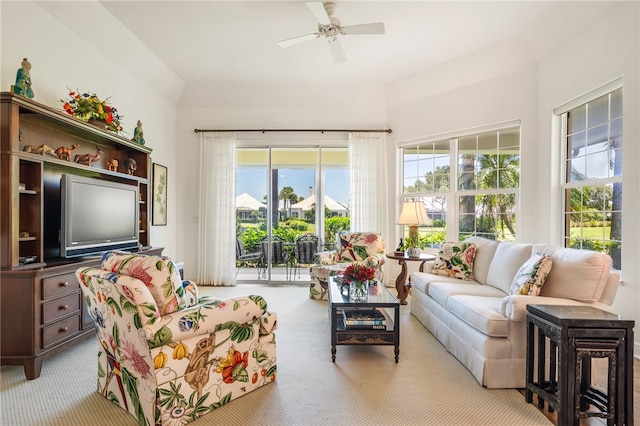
76,252,277,426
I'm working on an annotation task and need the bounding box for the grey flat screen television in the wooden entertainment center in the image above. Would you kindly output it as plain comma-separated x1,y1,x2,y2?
60,174,140,258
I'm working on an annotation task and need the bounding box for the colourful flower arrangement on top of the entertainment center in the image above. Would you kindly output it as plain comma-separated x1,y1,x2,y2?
60,89,122,133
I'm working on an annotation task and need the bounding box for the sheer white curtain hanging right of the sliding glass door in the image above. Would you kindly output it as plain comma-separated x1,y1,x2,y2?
349,132,391,241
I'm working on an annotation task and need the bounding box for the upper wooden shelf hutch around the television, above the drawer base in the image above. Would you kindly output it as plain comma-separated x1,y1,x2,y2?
0,92,151,269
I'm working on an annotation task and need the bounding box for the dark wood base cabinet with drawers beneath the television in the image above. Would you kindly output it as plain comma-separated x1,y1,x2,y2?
0,247,163,380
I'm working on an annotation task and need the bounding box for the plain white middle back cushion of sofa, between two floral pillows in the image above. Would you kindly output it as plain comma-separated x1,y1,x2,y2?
487,241,531,294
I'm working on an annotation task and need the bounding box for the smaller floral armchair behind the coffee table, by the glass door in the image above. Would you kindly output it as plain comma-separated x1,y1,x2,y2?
309,231,386,300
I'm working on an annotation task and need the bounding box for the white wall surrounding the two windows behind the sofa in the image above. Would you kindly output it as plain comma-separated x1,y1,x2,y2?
386,2,640,354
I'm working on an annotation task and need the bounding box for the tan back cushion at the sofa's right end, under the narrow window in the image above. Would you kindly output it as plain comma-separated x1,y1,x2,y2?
534,245,611,303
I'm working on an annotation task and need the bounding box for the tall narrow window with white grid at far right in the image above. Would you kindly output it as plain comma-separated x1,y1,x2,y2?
561,87,622,269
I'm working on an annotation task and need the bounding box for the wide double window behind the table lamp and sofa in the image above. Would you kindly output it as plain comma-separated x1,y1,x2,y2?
402,125,520,246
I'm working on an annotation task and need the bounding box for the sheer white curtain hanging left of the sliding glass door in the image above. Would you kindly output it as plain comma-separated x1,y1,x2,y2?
197,132,236,285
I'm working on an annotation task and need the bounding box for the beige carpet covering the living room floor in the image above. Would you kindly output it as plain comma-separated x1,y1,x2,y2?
0,285,550,426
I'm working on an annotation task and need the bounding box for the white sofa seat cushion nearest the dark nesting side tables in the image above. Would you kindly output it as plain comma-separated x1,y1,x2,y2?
447,294,509,337
